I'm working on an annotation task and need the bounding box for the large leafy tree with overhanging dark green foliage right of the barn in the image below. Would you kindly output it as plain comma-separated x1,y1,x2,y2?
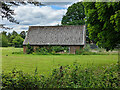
84,2,120,51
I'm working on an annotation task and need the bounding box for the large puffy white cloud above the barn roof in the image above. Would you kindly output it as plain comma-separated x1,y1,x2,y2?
15,5,67,25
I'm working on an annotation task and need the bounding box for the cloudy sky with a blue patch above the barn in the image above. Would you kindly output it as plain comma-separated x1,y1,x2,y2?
0,0,79,33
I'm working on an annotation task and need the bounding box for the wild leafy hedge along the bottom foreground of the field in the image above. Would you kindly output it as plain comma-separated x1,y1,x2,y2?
2,63,119,89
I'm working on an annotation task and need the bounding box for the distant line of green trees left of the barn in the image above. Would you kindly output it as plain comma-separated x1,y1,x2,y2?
0,31,27,47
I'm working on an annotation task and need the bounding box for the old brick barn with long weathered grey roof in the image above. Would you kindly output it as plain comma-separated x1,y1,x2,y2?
23,25,85,54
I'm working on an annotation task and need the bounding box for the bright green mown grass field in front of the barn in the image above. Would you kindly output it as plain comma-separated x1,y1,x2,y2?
0,48,118,74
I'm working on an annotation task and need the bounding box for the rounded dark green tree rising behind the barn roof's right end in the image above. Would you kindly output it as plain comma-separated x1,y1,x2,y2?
61,2,85,25
